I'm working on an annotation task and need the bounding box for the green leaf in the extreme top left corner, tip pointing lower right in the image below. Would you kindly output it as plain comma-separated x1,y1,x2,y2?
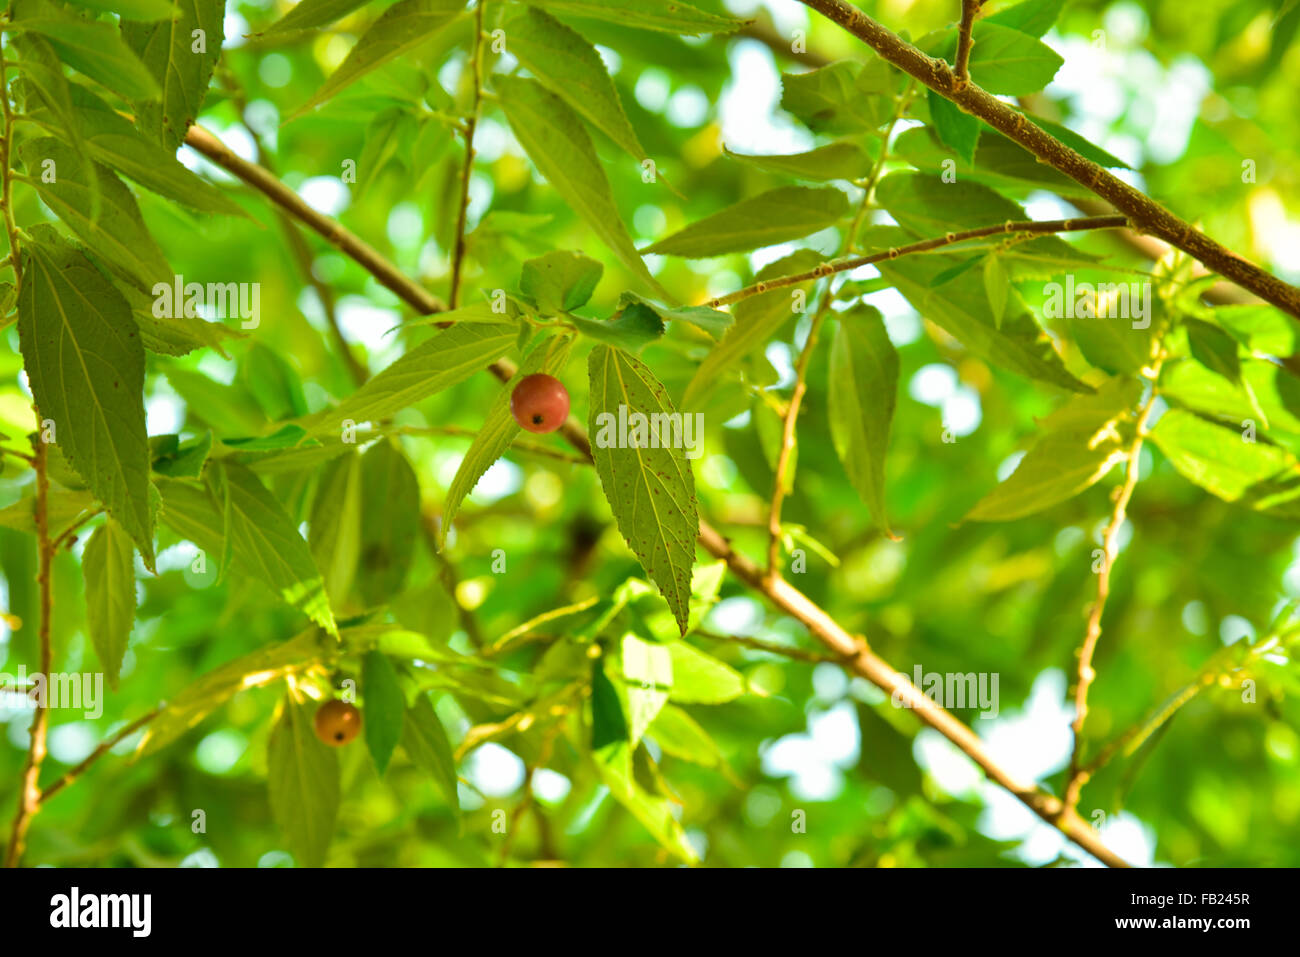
9,0,158,99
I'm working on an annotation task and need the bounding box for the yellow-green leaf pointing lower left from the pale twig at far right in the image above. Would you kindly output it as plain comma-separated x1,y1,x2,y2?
966,378,1139,521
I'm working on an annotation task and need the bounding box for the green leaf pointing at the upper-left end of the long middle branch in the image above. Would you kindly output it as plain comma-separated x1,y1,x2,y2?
29,85,247,218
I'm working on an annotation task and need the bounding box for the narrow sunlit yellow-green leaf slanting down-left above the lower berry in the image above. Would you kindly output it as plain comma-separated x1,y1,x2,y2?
135,631,333,758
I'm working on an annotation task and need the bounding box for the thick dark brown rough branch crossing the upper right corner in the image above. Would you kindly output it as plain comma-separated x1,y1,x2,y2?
800,0,1300,319
